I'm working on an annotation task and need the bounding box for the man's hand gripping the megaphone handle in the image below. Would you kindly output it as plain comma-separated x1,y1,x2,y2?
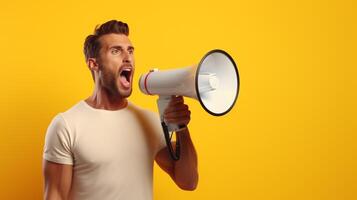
164,96,191,126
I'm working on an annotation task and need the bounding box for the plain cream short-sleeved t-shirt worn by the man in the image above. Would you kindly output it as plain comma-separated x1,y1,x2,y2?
43,100,165,200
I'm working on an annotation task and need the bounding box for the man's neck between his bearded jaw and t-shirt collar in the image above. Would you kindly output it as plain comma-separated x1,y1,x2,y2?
85,84,128,110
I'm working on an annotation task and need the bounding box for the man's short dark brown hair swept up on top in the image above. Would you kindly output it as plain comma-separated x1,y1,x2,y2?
83,20,129,61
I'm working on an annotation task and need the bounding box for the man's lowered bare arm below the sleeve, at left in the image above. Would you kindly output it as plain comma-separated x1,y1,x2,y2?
43,160,72,200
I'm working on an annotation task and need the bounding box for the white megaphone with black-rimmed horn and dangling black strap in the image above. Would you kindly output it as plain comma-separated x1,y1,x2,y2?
139,49,239,160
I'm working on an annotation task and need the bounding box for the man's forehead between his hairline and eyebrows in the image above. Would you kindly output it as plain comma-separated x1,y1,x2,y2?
99,33,133,49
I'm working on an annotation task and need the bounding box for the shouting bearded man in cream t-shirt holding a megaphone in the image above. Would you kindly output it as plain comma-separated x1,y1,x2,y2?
43,20,198,200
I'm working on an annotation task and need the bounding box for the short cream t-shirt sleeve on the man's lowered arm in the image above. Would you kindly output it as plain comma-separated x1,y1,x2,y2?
43,114,74,165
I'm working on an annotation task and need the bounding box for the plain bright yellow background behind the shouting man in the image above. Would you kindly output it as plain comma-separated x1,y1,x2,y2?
0,0,357,200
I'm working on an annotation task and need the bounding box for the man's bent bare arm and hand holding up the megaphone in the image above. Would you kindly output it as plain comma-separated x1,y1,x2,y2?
155,96,198,190
